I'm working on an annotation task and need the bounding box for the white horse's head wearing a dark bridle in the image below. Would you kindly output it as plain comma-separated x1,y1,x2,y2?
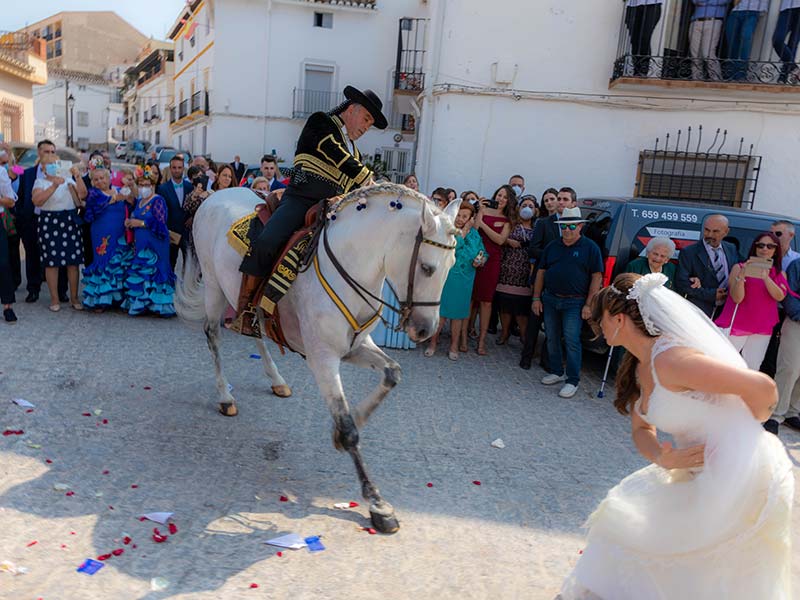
385,194,461,342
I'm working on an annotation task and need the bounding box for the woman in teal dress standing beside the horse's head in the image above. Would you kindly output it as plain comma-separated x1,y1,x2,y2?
425,202,486,360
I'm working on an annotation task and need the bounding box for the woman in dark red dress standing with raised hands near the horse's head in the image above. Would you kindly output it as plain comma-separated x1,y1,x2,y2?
470,185,517,356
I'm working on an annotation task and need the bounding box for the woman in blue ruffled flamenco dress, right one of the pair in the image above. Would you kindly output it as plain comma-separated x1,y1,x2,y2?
122,167,175,317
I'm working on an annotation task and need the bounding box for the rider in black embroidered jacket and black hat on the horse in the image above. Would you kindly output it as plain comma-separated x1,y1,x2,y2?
231,86,387,336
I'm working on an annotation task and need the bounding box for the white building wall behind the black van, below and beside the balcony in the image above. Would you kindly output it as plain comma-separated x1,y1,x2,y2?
417,0,800,217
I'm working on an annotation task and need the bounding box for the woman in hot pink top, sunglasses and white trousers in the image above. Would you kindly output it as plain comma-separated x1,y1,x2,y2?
715,231,789,371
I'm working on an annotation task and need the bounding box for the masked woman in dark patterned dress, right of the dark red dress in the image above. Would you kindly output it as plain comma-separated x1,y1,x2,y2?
495,196,536,346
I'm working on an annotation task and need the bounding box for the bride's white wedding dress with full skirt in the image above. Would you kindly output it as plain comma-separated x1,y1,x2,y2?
561,336,794,600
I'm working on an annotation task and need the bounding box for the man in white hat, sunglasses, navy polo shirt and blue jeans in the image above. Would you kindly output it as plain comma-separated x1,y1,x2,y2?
531,207,603,398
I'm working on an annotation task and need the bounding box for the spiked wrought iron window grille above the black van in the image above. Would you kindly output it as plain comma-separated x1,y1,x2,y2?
634,125,761,208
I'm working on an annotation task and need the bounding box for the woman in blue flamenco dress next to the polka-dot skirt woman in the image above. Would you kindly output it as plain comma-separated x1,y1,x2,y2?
83,158,133,312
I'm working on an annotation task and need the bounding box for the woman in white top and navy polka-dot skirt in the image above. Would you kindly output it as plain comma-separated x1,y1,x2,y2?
32,155,86,312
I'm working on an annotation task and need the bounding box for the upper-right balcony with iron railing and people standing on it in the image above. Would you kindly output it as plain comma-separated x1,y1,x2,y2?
609,0,800,93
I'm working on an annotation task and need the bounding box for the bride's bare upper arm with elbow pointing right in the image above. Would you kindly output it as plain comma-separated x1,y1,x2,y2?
655,348,778,423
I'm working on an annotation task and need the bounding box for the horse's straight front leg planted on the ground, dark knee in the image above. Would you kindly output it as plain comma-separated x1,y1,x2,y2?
307,350,400,533
